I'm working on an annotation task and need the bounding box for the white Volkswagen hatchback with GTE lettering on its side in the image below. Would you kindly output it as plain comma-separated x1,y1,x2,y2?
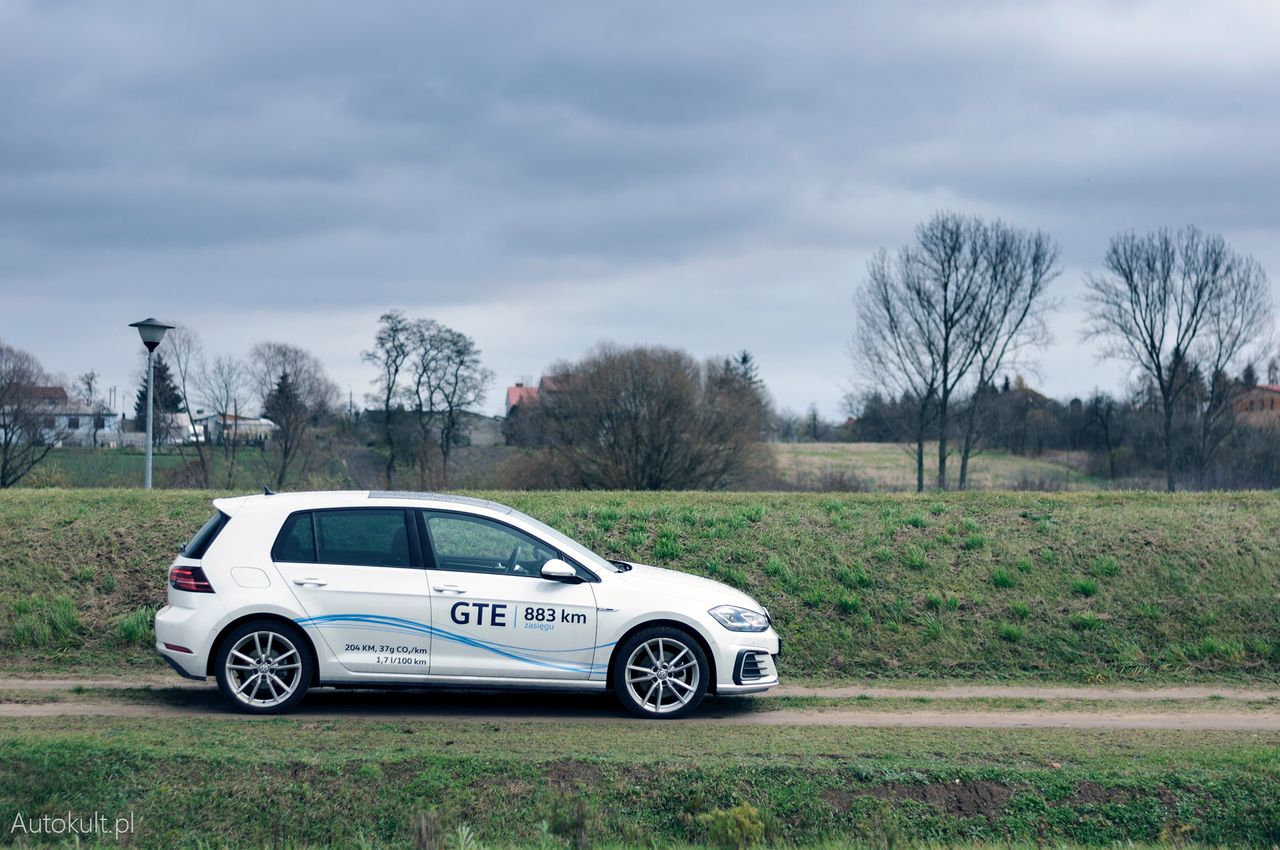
156,492,780,718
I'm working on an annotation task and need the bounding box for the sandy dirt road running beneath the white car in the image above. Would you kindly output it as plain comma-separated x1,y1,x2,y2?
0,677,1280,732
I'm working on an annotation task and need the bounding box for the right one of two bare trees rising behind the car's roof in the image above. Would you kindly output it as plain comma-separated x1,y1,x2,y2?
407,319,493,486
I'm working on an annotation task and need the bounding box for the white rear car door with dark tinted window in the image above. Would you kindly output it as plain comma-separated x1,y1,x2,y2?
271,508,431,676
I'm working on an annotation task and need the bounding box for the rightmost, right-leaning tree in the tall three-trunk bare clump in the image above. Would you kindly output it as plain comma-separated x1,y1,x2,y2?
959,221,1061,490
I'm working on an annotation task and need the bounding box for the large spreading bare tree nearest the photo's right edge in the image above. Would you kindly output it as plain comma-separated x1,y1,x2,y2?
1085,227,1256,493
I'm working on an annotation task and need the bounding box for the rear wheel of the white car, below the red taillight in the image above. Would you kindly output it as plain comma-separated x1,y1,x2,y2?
214,620,315,714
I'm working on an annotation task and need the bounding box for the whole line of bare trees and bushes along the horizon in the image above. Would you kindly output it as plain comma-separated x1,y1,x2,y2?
0,213,1280,490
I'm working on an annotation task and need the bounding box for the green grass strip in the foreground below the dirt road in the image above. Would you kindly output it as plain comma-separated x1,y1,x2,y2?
0,717,1280,847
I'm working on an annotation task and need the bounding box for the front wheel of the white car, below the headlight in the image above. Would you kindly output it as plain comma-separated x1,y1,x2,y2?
612,626,710,719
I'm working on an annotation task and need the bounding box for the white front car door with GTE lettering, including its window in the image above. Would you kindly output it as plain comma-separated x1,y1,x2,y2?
419,511,605,680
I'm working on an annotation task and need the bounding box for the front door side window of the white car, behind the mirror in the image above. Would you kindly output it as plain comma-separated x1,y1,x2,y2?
424,512,559,576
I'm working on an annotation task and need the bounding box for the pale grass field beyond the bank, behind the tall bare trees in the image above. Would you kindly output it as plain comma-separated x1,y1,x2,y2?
769,442,1097,492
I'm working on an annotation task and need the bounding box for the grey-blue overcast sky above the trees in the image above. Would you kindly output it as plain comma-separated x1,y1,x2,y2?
0,0,1280,417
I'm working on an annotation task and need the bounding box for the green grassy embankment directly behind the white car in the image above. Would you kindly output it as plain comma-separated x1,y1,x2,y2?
0,490,1280,681
